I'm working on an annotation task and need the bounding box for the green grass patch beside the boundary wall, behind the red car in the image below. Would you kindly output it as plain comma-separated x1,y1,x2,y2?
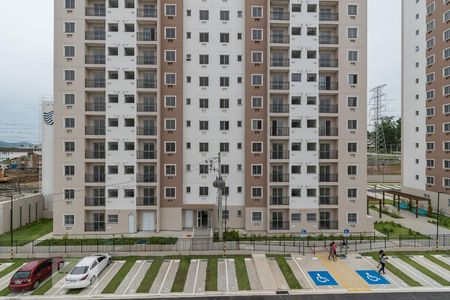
0,219,53,246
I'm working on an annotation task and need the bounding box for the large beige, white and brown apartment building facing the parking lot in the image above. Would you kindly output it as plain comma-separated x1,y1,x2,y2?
53,0,373,234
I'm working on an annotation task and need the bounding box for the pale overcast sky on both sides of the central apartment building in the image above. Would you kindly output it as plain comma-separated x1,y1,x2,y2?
0,0,401,142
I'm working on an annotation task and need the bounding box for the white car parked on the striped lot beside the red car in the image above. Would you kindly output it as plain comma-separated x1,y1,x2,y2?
64,253,111,289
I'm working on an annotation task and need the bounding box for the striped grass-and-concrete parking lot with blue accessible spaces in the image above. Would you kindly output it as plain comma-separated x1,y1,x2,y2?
0,253,450,298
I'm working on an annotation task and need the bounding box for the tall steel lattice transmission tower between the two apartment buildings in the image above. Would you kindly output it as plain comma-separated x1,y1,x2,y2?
369,84,386,170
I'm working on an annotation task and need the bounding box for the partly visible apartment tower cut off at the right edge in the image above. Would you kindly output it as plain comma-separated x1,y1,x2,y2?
402,0,450,213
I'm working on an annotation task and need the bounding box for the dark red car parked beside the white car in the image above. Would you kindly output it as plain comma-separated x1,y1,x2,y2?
9,257,64,292
